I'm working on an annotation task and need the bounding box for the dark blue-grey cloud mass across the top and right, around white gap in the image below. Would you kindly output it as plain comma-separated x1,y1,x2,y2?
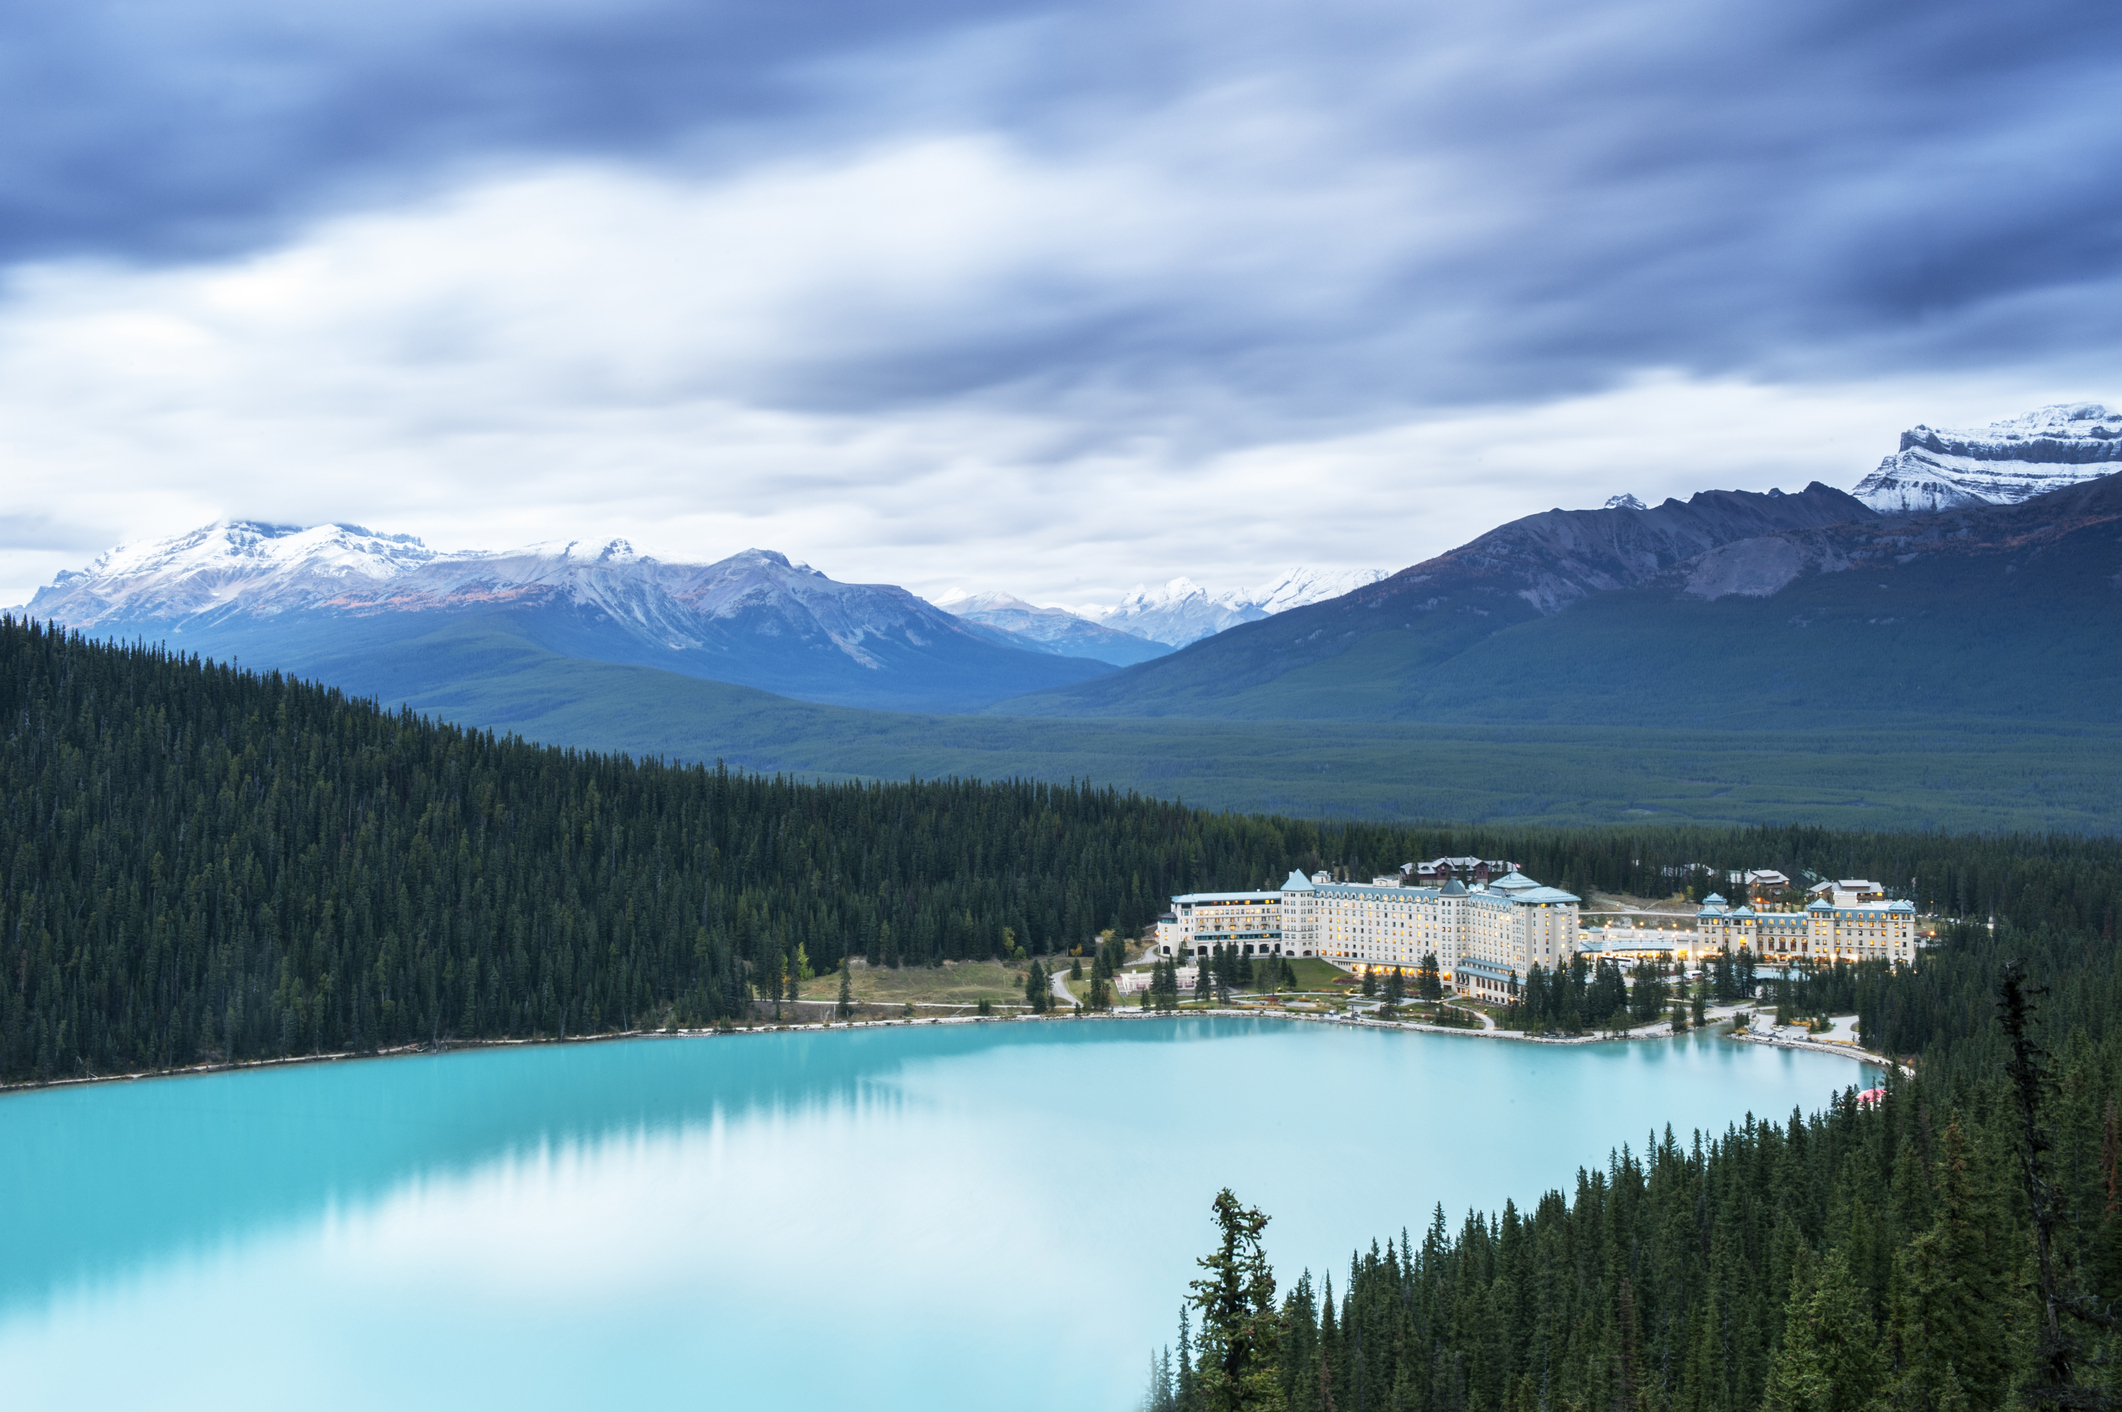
0,0,2122,423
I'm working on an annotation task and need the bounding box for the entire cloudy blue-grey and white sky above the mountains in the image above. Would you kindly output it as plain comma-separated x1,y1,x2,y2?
0,0,2122,603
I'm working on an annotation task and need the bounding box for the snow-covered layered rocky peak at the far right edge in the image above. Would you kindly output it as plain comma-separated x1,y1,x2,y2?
1855,401,2122,514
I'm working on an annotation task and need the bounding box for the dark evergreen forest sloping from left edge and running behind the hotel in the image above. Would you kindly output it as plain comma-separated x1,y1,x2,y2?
0,620,2122,1079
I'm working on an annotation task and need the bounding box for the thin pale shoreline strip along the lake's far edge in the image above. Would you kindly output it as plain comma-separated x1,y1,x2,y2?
0,1006,1912,1098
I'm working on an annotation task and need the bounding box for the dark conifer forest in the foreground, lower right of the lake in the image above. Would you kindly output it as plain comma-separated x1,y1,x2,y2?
1146,904,2122,1412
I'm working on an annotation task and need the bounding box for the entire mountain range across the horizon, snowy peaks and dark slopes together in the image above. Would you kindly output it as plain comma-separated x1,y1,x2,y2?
28,403,2122,807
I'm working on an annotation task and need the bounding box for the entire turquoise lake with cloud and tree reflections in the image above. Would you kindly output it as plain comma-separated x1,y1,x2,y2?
0,1019,1874,1412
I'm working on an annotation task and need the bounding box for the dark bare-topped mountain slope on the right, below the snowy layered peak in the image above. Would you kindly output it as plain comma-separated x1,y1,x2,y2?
995,476,2122,728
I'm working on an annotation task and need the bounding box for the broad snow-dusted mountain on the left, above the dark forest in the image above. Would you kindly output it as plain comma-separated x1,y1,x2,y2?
25,520,1103,709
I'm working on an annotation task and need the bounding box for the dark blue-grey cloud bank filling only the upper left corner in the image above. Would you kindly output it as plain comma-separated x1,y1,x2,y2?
0,0,1010,259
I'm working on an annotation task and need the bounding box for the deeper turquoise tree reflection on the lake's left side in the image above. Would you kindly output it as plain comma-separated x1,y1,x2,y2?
0,1019,1254,1310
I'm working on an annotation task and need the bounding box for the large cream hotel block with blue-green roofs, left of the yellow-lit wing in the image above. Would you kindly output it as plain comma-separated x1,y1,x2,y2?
1156,871,1579,1000
